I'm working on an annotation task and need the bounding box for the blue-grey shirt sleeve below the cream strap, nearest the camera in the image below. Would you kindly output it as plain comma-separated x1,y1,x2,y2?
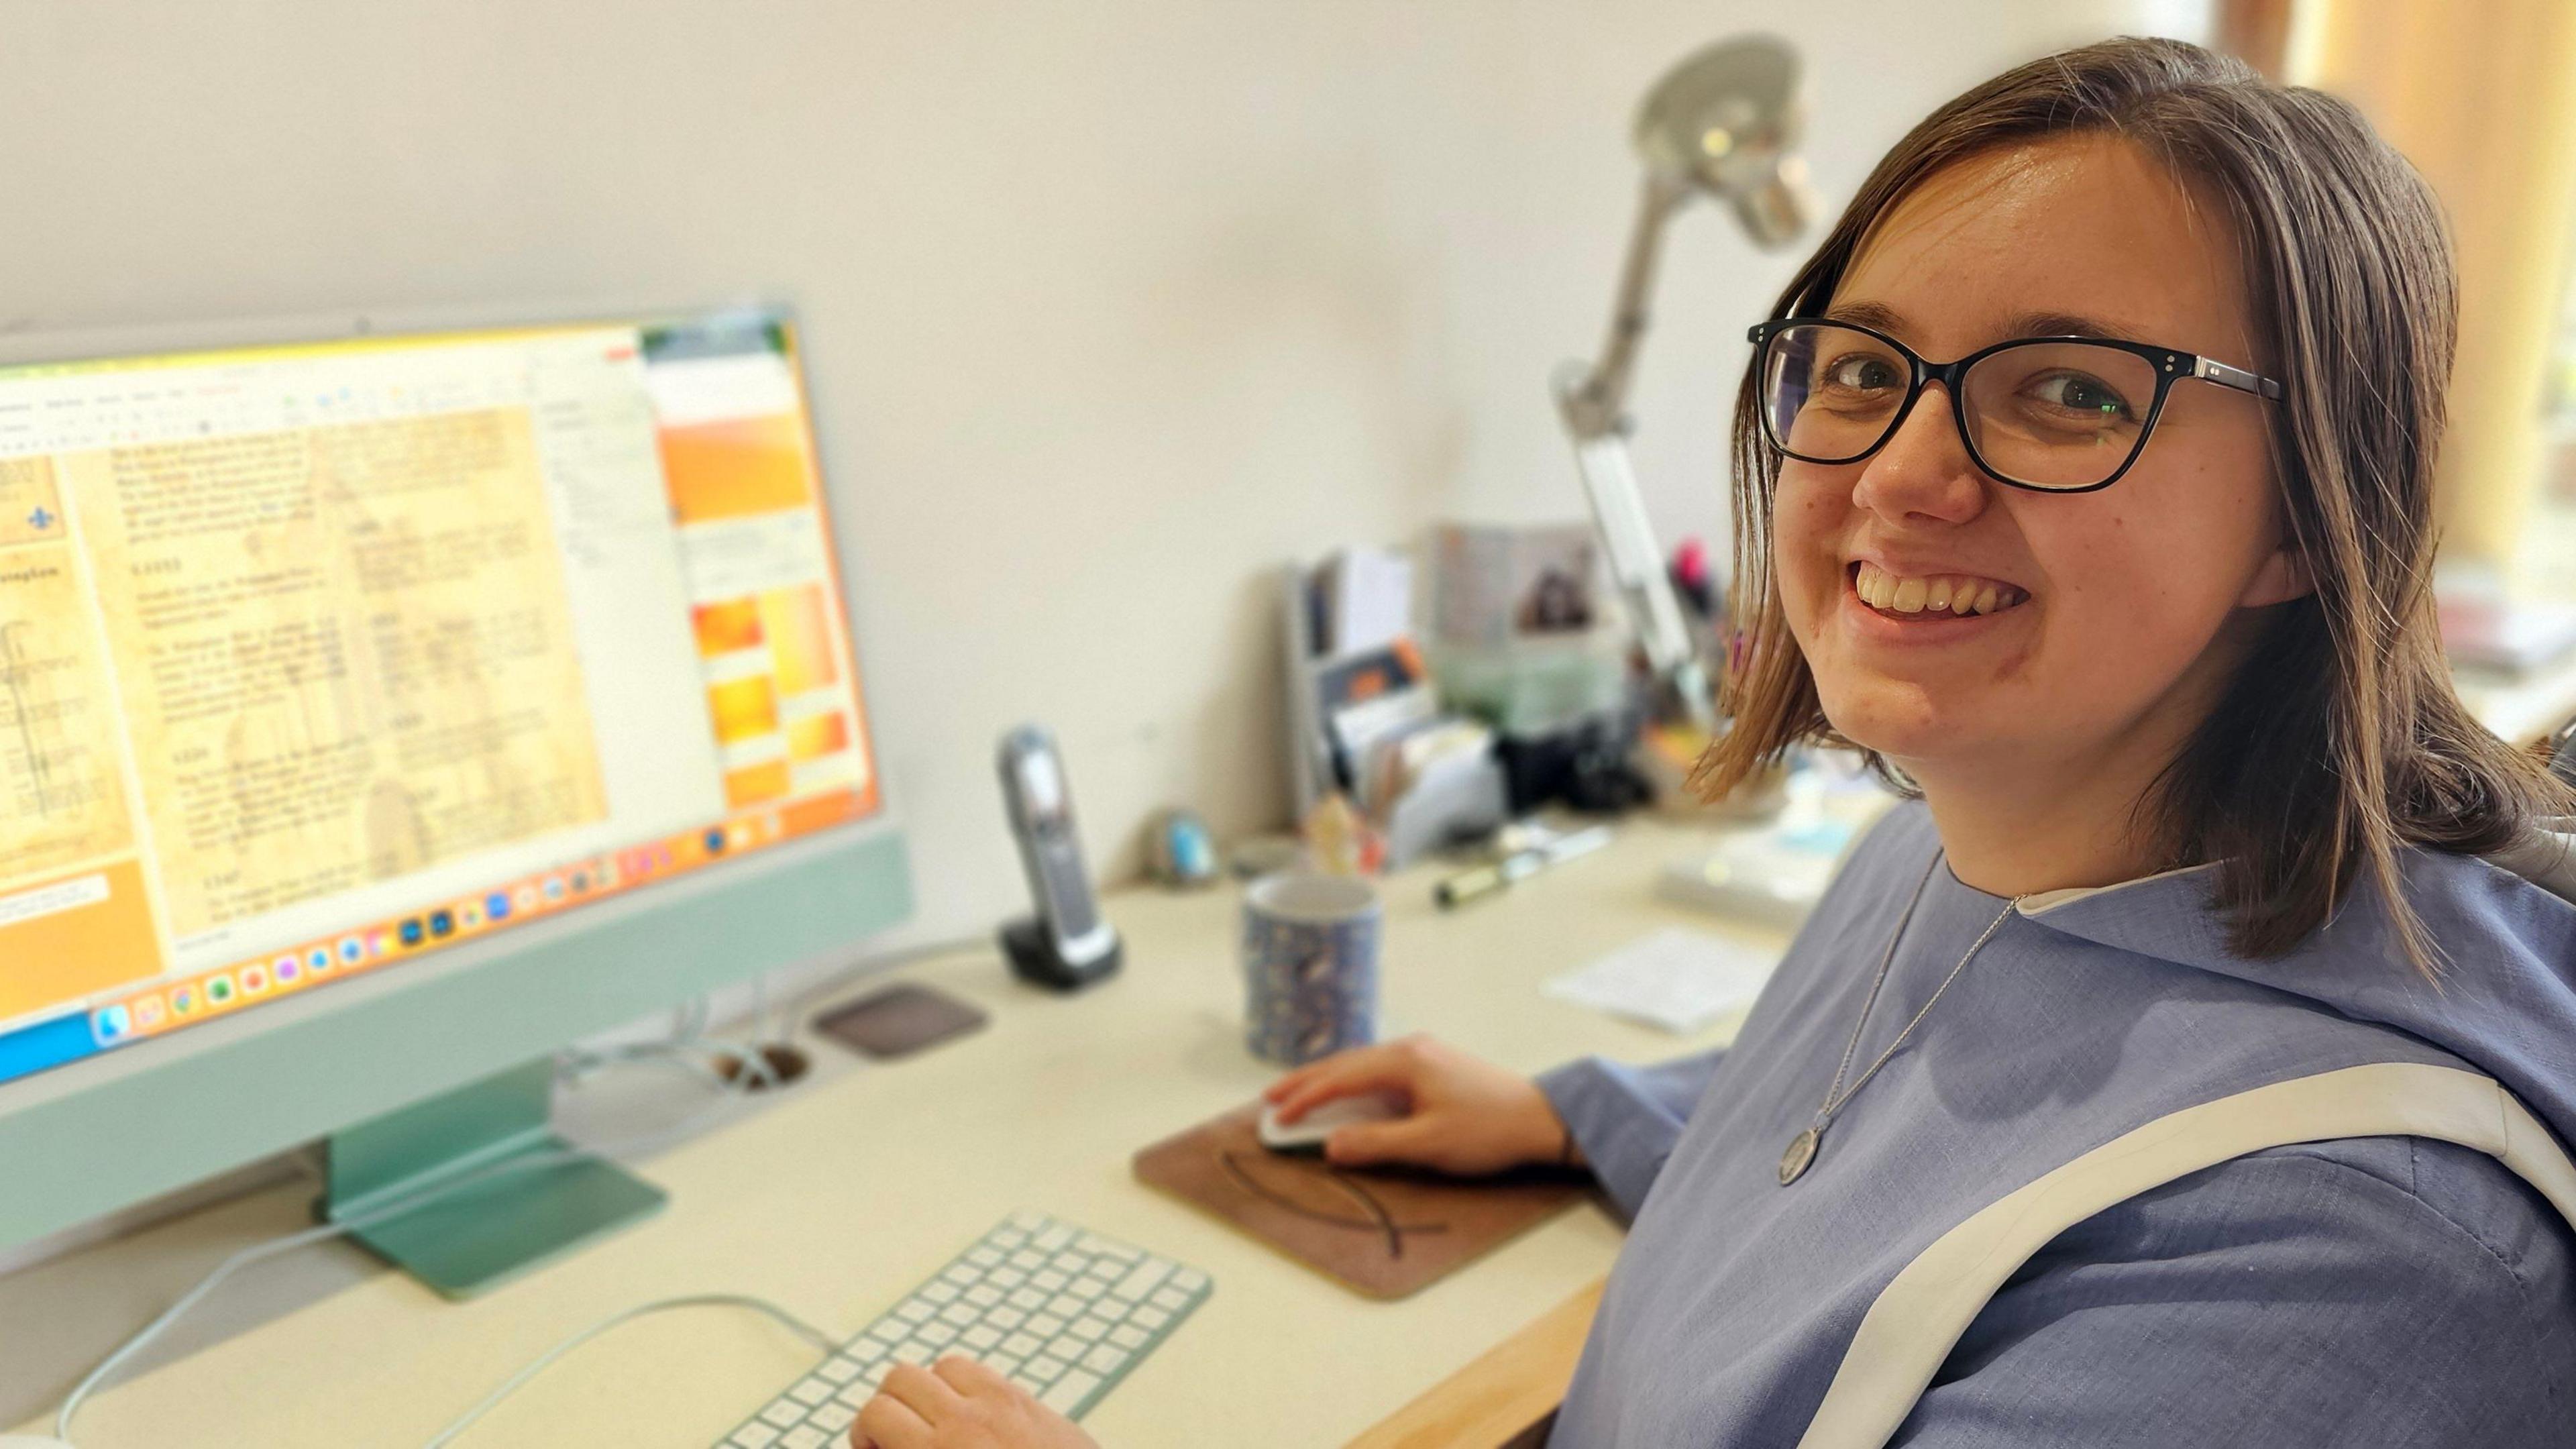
1888,1137,2576,1449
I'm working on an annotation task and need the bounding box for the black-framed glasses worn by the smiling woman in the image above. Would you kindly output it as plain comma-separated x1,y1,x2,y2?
1749,317,2279,492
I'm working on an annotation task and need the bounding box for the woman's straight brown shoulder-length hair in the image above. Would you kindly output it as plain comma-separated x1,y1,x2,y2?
1693,39,2576,972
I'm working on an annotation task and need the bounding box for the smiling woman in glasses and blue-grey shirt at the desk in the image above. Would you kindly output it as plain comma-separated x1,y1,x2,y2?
861,41,2576,1449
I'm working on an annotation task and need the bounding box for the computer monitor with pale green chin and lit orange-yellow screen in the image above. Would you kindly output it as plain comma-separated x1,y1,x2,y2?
0,309,910,1292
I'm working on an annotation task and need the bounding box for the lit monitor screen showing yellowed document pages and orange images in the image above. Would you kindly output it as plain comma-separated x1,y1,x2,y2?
0,312,878,1080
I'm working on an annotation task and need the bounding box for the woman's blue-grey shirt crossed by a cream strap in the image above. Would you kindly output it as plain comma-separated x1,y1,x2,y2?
1540,804,2576,1449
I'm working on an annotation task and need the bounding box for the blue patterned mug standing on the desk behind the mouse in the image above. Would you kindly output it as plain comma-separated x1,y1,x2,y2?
1244,871,1381,1067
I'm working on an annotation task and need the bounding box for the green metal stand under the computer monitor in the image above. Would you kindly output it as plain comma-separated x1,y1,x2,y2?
314,1057,667,1299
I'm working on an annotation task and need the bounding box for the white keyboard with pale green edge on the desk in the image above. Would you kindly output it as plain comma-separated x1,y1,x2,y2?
716,1212,1216,1449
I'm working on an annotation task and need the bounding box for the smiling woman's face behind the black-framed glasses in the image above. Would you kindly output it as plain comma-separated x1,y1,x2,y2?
1772,137,2300,789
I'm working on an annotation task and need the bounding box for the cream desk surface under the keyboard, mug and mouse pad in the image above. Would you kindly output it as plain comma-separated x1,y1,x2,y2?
0,820,1785,1449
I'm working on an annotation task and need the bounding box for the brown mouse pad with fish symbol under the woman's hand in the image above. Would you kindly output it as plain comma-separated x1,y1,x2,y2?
1136,1104,1587,1299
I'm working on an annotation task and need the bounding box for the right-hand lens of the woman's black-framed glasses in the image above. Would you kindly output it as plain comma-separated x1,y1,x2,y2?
1963,343,2156,487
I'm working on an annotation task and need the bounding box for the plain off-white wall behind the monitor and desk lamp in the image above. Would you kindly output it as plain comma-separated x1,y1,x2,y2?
0,0,2208,936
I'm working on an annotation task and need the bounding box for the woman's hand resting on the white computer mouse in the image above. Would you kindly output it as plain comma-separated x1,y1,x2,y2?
1263,1036,1579,1176
